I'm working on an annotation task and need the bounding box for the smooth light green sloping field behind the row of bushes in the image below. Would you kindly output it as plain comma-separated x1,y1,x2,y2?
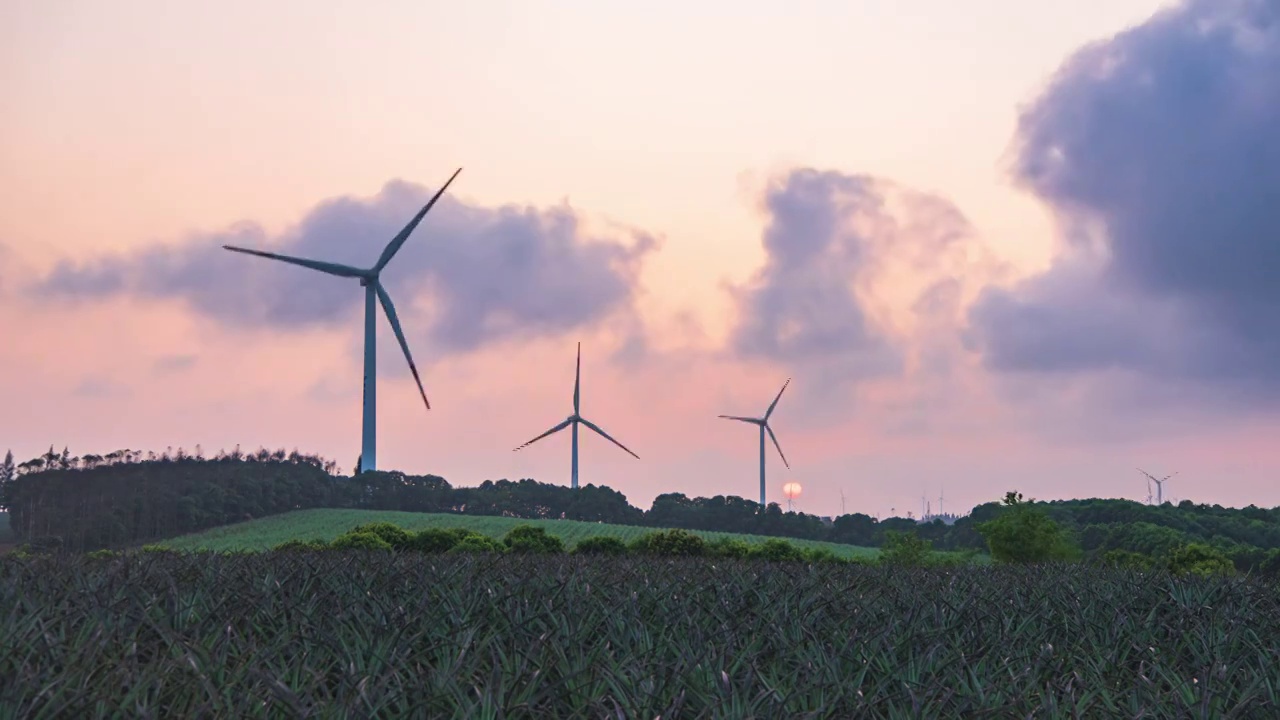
156,510,879,557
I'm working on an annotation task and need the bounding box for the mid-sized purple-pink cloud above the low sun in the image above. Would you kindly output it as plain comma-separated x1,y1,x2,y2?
731,169,969,386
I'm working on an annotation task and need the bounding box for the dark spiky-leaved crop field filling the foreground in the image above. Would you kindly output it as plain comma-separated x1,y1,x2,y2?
0,548,1280,719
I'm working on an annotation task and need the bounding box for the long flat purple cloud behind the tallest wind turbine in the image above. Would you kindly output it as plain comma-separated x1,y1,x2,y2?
36,181,657,363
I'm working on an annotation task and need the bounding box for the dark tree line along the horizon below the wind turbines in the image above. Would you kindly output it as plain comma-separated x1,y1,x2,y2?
0,446,1280,570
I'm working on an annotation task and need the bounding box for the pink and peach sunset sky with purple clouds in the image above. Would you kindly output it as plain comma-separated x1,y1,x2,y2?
0,0,1280,518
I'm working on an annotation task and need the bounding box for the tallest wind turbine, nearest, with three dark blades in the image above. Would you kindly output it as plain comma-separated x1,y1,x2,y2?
223,168,462,473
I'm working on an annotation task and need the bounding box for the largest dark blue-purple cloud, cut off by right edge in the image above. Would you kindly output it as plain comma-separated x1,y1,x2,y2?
968,0,1280,406
